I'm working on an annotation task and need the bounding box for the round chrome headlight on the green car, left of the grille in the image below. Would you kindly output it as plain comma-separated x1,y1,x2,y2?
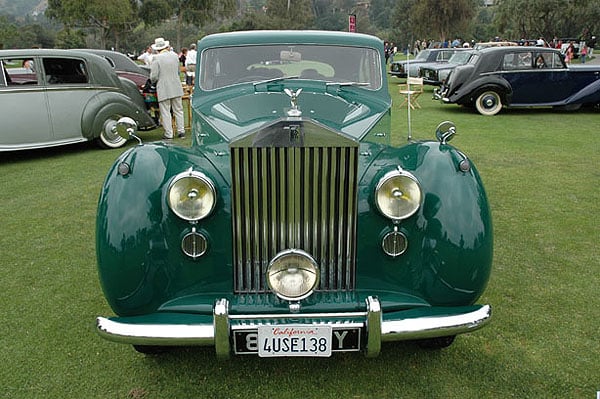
167,170,217,221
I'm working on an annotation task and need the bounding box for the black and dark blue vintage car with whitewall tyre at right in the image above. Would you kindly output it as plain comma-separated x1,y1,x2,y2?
438,46,600,115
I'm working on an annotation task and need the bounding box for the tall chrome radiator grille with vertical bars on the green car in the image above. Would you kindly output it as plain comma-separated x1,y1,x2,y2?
231,145,358,293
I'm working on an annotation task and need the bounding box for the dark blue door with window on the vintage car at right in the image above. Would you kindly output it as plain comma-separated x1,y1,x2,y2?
503,51,573,105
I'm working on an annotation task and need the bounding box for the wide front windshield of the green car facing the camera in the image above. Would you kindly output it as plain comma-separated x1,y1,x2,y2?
200,45,383,90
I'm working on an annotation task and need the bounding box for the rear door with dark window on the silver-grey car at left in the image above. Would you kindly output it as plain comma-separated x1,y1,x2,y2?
43,57,97,143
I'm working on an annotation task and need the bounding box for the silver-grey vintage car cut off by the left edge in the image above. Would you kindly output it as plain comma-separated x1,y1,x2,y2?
0,49,155,151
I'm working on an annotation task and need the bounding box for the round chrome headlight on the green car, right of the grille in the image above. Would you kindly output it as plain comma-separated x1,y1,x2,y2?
375,170,423,220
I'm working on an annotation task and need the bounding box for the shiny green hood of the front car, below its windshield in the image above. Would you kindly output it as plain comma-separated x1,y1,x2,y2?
193,87,391,141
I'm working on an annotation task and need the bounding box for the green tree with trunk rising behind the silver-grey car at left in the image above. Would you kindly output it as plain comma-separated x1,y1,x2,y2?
46,0,137,48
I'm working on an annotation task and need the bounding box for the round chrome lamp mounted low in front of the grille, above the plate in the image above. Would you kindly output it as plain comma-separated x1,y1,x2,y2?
267,249,319,301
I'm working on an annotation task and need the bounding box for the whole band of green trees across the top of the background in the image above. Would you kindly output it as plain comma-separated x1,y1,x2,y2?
0,0,600,51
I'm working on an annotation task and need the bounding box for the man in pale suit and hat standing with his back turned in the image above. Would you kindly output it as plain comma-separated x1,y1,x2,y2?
150,37,185,139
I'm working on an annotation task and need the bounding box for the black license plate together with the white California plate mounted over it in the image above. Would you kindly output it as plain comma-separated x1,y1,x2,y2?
233,324,361,357
